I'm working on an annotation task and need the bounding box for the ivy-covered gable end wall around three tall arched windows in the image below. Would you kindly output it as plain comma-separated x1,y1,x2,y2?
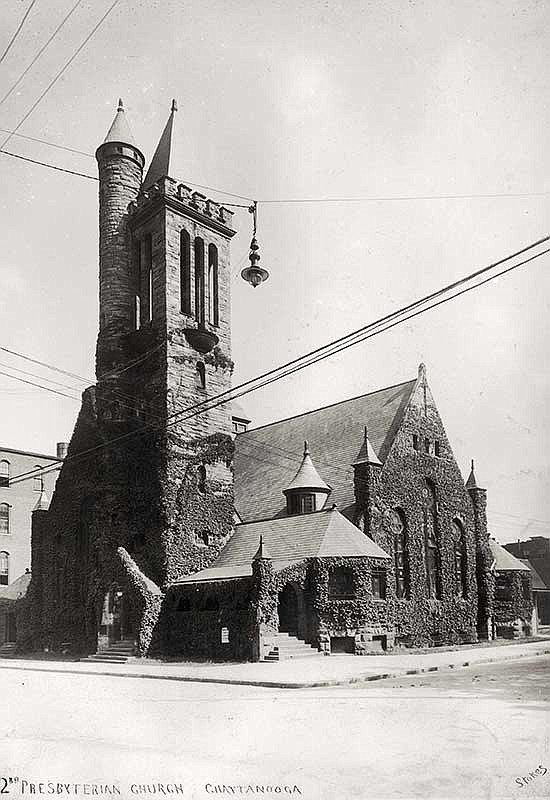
355,370,490,646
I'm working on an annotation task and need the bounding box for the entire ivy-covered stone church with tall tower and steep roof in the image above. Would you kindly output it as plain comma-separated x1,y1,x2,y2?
19,103,530,660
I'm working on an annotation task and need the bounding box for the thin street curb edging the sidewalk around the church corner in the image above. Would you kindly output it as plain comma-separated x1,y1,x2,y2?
0,645,550,689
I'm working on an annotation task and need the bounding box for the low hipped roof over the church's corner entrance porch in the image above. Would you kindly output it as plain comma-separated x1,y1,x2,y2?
176,508,389,584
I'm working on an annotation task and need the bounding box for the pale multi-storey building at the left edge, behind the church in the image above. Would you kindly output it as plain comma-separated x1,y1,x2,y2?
0,442,66,645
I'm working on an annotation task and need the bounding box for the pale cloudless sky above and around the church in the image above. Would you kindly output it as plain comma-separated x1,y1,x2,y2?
0,0,550,542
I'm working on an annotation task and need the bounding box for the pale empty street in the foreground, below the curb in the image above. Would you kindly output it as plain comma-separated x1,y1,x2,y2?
0,656,550,800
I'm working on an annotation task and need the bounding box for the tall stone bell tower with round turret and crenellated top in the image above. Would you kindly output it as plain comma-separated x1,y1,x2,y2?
96,101,235,585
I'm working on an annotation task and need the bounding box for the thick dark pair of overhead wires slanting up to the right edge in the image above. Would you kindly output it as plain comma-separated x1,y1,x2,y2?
8,236,550,482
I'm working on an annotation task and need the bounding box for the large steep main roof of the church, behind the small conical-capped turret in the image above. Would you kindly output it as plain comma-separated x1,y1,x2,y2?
234,380,416,521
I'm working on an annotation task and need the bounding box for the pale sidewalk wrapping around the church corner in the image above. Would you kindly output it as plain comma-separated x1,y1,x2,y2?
0,638,550,689
